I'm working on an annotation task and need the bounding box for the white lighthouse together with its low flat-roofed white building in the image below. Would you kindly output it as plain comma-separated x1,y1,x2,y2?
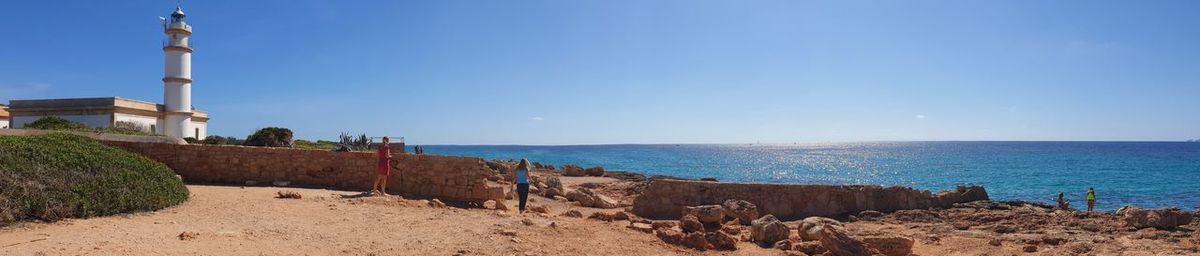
0,6,209,138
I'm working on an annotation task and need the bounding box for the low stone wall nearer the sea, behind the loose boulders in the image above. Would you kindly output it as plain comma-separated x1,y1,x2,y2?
632,179,988,220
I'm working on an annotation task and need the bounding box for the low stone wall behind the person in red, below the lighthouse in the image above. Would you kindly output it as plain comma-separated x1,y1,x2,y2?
102,141,509,202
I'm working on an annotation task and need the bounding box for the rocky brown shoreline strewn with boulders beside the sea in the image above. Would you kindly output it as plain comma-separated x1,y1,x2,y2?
488,159,1200,256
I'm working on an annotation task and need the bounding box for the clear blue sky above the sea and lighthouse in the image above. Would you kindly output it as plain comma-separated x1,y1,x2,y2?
0,0,1200,144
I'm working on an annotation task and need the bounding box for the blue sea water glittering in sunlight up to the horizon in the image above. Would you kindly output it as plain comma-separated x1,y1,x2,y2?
415,142,1200,210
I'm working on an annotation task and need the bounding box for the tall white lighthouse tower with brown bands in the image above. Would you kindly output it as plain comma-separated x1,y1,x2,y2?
162,5,192,139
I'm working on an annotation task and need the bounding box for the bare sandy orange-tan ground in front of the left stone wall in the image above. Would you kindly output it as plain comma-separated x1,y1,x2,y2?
0,185,781,255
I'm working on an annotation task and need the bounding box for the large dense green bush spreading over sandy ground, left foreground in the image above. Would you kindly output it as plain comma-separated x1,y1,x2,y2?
0,133,187,225
